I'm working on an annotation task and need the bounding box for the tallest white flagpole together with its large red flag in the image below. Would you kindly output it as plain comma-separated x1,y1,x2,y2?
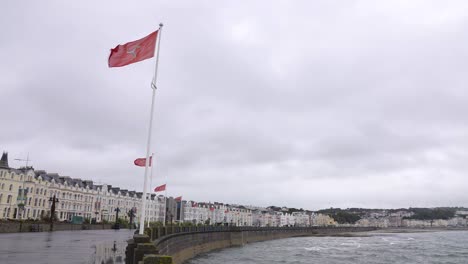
108,23,163,234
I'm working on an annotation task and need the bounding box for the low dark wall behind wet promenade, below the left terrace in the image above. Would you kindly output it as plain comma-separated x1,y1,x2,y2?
0,221,111,233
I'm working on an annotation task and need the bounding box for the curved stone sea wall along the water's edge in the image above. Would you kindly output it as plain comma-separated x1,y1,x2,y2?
126,227,376,264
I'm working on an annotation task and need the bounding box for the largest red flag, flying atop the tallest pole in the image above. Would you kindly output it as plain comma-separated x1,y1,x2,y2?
108,30,158,67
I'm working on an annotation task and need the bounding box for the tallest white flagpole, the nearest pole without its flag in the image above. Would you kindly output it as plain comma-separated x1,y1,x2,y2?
139,23,163,235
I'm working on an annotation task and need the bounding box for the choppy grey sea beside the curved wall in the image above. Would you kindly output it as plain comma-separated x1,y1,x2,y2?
188,231,468,264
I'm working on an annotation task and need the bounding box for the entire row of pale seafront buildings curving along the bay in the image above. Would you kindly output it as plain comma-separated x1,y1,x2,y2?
0,153,468,227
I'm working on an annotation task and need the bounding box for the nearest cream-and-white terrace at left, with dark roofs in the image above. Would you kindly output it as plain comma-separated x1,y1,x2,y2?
0,153,165,223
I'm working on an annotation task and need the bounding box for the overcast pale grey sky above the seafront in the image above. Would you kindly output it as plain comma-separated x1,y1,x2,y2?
0,0,468,209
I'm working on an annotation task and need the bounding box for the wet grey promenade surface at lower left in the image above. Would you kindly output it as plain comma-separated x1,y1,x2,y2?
0,229,135,264
